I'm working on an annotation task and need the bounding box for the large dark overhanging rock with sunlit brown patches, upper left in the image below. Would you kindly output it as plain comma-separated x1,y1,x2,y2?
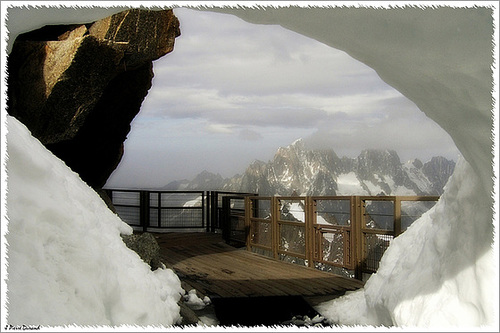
7,9,180,188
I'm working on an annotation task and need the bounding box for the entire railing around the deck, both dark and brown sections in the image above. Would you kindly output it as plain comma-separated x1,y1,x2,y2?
106,189,439,279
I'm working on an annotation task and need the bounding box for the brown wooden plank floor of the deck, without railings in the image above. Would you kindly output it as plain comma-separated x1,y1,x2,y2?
154,233,363,298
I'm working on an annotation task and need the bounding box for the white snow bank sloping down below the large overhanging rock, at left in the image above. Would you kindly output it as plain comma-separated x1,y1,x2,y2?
6,117,183,326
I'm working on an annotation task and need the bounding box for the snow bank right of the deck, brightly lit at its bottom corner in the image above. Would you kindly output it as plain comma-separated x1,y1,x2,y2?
318,159,497,328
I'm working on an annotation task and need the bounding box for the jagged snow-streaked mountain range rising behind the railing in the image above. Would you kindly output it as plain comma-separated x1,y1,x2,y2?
162,139,455,195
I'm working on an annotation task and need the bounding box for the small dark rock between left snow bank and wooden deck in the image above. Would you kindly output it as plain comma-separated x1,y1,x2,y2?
122,232,163,271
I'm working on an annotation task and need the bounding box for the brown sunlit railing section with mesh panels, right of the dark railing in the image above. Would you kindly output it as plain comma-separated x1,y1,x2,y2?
245,196,439,279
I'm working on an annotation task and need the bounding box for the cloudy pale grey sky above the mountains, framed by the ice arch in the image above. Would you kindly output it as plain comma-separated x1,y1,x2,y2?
7,8,458,188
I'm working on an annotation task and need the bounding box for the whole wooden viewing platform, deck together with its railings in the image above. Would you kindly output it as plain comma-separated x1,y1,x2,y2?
108,189,439,326
